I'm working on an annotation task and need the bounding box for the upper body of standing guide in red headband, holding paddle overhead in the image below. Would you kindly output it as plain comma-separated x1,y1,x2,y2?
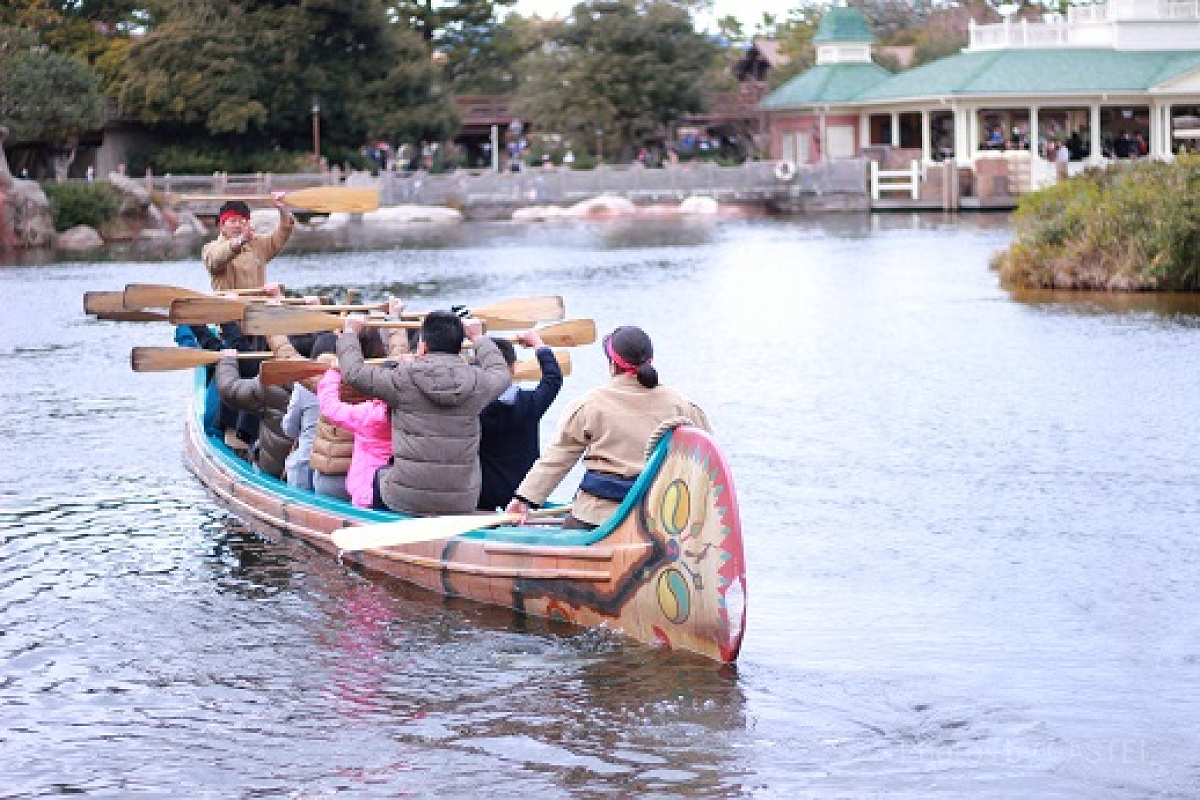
200,192,295,291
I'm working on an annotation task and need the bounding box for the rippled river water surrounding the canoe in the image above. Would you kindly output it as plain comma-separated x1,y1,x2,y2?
0,215,1200,799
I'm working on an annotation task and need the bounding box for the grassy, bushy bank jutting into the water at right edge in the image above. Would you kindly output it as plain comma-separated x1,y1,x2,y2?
991,156,1200,291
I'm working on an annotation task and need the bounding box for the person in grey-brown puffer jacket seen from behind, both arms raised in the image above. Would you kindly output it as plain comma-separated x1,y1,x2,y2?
337,311,512,515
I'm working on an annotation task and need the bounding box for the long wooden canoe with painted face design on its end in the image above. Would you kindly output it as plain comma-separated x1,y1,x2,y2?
186,369,746,663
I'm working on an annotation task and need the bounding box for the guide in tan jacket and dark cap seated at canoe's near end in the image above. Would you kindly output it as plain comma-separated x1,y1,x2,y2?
508,325,710,528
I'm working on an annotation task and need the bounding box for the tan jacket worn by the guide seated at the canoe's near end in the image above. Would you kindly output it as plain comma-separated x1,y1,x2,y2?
516,374,712,525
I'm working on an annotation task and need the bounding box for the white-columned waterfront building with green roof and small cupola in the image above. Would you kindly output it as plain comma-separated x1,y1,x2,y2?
761,0,1200,195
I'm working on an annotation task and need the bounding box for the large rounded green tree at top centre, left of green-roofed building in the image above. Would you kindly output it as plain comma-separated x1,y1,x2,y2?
520,0,718,161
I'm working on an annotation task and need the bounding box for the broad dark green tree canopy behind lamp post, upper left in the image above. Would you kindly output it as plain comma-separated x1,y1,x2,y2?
120,0,455,159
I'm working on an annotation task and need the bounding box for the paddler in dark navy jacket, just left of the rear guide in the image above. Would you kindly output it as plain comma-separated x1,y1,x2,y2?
479,331,563,511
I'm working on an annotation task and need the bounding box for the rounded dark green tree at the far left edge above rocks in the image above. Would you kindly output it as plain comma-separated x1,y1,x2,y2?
0,28,104,182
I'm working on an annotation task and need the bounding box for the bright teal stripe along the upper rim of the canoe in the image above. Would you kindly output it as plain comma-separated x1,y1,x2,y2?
192,367,673,547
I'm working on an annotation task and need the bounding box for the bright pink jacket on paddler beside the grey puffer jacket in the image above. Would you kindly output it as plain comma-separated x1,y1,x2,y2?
317,369,391,509
